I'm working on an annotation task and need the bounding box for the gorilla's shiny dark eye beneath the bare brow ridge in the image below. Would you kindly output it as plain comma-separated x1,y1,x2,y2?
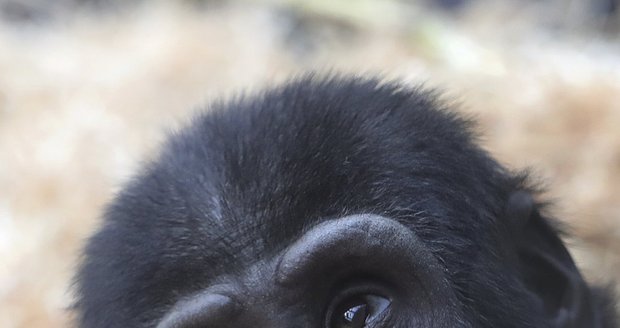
327,294,390,328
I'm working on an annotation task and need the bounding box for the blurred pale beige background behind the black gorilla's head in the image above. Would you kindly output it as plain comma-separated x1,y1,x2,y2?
0,0,620,327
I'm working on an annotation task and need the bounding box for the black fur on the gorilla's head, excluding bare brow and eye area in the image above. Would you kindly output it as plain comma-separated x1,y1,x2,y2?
76,77,615,328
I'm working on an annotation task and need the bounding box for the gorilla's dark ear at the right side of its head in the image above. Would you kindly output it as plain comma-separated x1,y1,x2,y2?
506,191,593,327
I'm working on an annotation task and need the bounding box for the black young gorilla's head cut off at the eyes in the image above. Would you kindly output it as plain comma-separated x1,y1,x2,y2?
76,77,614,328
